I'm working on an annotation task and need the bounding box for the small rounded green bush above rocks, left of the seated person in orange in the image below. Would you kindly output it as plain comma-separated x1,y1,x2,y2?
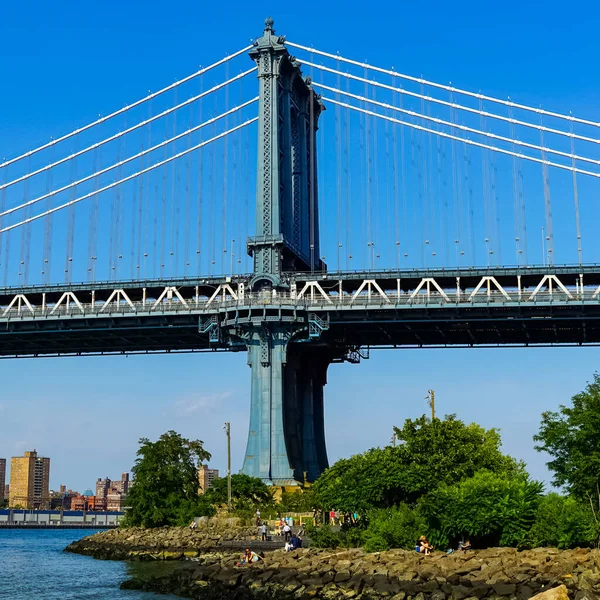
362,504,427,552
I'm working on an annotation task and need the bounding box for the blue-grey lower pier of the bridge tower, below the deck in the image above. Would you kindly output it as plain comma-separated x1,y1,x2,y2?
242,324,332,485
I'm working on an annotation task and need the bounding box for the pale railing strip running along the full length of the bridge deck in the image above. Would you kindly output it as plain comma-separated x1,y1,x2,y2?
0,288,600,321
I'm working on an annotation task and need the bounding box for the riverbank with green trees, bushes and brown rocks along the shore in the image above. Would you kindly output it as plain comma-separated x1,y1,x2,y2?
68,374,600,600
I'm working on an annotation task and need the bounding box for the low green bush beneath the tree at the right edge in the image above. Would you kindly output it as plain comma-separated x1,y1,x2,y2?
527,494,597,549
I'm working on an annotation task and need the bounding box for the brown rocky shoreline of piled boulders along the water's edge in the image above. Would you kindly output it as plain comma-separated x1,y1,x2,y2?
68,527,600,600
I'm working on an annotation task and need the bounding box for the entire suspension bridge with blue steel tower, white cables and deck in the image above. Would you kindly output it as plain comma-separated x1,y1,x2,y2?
0,19,600,485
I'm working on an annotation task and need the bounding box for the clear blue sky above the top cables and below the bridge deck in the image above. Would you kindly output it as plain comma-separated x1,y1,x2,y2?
0,0,600,491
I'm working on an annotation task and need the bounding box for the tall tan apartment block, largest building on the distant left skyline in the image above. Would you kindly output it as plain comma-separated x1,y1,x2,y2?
8,450,50,509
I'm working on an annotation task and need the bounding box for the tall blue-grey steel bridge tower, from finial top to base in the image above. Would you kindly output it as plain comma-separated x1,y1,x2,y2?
239,18,335,486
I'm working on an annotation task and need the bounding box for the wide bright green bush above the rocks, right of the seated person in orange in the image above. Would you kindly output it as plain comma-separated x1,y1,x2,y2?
420,471,543,548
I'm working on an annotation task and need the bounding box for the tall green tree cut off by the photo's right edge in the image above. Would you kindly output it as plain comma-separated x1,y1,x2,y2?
533,373,600,514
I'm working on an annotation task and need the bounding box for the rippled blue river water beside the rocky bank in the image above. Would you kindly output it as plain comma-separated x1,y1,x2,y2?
0,528,180,600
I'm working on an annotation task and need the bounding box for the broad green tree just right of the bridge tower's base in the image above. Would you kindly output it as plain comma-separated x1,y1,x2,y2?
313,415,524,516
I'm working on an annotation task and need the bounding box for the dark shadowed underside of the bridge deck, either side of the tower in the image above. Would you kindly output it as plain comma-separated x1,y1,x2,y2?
0,302,600,357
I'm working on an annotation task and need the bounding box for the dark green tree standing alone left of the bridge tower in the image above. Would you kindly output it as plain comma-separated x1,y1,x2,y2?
125,431,214,527
